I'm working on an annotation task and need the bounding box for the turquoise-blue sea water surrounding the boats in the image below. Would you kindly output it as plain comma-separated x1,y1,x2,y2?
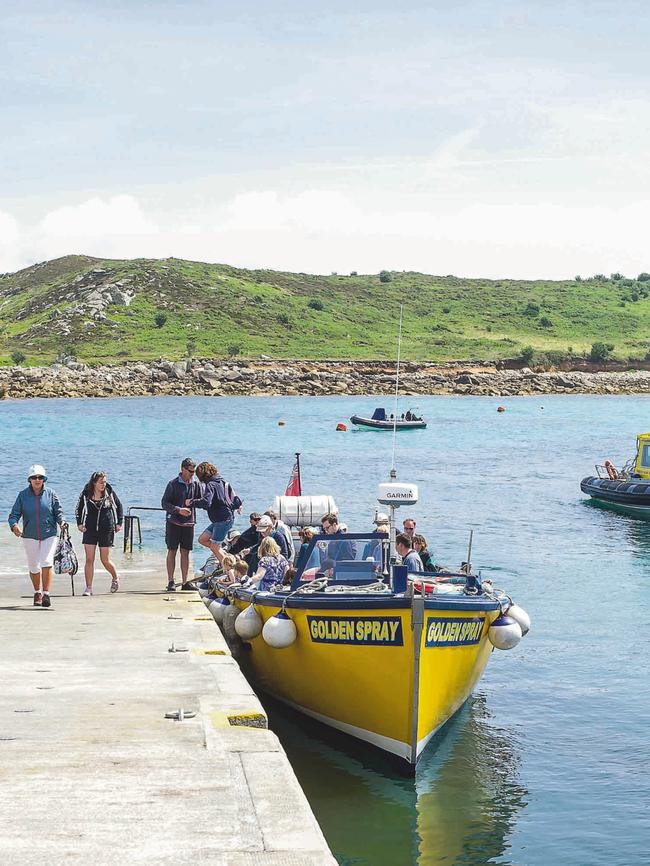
0,396,650,866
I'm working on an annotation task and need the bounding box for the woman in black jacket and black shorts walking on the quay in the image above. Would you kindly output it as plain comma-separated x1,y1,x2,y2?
76,472,124,595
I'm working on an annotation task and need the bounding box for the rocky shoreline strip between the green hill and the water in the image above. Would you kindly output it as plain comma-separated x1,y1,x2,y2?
0,359,650,398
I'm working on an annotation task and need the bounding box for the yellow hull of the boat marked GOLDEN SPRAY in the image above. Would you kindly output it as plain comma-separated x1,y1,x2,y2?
227,592,498,768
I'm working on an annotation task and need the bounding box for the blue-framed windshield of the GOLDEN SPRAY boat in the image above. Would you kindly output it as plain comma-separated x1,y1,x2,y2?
292,532,390,588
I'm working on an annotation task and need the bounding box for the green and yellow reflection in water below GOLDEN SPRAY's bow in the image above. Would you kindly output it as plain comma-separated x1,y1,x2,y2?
265,695,527,866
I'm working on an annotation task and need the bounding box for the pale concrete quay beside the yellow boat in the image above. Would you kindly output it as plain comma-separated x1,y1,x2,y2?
0,573,336,866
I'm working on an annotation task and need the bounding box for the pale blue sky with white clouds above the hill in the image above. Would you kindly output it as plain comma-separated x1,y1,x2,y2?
0,0,650,279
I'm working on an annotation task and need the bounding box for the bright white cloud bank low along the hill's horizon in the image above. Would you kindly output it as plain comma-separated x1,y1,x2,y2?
0,189,650,279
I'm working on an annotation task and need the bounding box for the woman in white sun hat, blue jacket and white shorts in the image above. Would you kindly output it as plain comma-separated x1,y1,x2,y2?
9,463,65,607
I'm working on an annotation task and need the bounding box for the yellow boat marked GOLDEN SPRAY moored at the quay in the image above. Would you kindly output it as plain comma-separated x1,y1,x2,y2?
210,482,529,768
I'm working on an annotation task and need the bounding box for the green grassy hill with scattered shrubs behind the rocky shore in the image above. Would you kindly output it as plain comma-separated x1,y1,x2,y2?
0,256,650,364
